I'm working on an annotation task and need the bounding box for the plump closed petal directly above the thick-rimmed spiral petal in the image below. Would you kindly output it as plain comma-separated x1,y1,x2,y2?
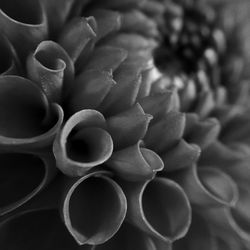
67,70,116,114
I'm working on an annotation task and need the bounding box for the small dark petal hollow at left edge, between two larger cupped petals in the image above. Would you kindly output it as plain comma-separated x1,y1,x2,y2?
0,35,20,75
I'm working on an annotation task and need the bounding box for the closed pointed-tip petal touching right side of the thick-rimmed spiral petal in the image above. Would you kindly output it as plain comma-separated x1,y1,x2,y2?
107,104,152,150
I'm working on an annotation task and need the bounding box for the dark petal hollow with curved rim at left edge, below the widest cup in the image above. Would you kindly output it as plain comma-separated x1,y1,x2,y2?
0,153,56,215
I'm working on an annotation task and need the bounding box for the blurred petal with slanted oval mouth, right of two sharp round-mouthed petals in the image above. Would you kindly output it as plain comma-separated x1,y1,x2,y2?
173,165,238,207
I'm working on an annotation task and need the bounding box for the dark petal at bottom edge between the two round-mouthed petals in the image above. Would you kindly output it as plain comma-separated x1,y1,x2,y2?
91,222,155,250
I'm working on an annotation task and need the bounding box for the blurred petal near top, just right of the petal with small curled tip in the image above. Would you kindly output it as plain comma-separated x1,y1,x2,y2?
88,9,121,41
